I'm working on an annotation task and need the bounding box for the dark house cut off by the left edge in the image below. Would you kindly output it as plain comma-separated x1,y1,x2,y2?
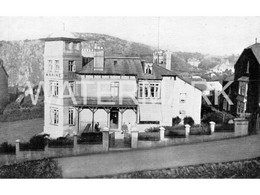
0,59,9,111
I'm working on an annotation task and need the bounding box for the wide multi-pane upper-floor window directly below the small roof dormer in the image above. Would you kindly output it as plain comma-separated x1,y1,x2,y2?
138,83,160,98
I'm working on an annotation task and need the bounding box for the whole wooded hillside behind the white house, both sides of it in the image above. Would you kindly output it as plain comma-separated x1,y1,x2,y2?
0,33,237,86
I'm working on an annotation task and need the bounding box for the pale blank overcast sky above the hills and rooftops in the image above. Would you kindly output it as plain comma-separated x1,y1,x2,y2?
0,16,260,55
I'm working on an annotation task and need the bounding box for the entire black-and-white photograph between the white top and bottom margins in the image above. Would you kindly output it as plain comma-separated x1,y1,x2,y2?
0,2,260,187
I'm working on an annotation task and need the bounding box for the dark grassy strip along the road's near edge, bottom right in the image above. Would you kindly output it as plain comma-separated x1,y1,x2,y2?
96,157,260,178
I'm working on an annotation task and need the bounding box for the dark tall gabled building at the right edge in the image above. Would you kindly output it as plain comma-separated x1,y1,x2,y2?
232,43,260,117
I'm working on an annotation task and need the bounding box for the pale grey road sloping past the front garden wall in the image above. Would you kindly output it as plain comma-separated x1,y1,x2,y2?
56,135,260,178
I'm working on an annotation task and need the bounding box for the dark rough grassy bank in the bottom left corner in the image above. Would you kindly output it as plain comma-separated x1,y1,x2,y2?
0,159,62,178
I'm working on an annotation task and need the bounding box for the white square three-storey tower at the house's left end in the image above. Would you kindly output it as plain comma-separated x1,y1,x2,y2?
42,32,83,138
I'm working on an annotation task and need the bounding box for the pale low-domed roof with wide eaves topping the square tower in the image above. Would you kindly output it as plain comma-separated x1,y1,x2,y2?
41,31,84,42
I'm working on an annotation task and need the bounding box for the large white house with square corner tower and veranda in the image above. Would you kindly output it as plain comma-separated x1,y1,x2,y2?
43,33,202,137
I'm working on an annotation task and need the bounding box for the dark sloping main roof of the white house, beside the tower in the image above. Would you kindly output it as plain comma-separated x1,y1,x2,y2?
77,57,176,80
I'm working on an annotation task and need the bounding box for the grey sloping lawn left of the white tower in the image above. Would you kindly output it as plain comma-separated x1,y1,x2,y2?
0,118,44,144
